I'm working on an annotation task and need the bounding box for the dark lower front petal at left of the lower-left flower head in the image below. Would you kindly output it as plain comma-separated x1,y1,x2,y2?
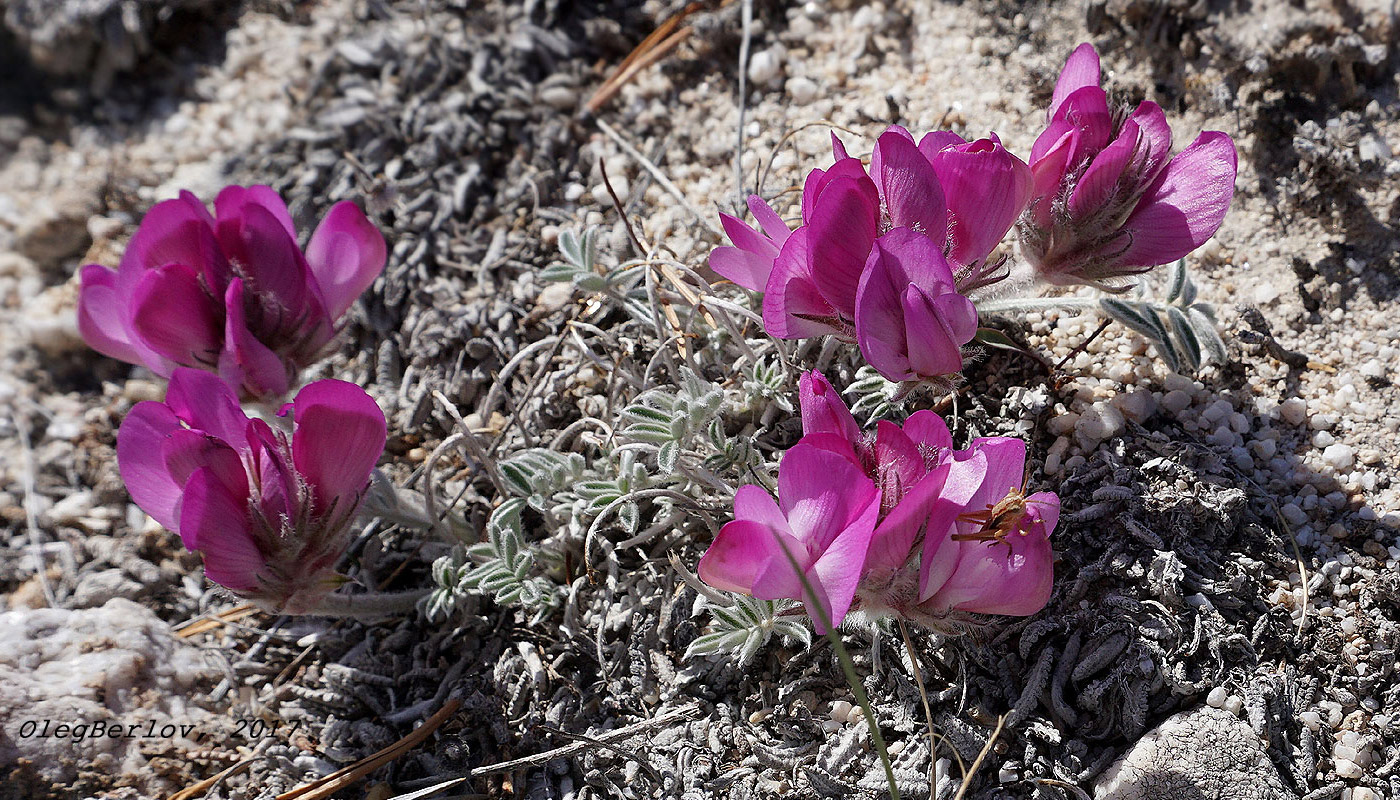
179,468,267,591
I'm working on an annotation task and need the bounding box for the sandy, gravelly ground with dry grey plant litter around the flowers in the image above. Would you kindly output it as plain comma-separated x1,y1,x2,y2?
0,0,1400,800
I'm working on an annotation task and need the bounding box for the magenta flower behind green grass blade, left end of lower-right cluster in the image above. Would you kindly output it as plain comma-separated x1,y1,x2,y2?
699,443,879,633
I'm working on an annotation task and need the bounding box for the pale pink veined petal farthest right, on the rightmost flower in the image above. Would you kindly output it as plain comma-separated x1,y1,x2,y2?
1114,130,1236,266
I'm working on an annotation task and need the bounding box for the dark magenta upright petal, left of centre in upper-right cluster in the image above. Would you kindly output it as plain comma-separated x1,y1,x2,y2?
808,178,879,317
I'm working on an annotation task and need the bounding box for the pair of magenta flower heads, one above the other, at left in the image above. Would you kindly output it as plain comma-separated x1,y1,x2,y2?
78,186,386,614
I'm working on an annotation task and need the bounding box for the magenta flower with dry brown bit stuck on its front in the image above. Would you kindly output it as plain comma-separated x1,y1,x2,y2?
920,437,1060,616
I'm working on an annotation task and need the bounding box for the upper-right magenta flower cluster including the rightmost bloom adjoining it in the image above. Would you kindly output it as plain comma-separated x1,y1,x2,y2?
710,45,1236,381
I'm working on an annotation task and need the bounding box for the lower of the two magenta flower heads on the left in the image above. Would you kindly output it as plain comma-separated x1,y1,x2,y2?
116,367,386,614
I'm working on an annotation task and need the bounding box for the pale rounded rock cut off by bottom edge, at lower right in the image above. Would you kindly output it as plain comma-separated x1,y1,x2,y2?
1093,706,1295,800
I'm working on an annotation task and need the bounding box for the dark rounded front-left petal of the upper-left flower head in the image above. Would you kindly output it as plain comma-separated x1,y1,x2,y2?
132,263,223,367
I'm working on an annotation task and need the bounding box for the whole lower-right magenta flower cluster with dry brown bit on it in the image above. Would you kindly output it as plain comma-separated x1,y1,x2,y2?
699,371,1060,632
